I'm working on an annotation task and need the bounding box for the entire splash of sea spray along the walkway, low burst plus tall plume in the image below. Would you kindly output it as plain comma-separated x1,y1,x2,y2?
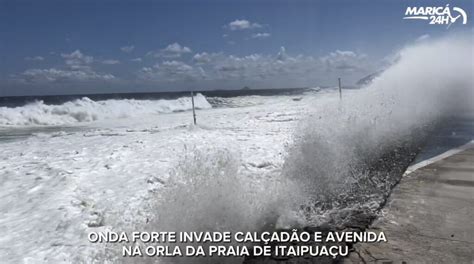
135,33,473,263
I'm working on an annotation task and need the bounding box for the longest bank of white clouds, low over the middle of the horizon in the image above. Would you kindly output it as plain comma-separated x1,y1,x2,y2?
150,47,374,87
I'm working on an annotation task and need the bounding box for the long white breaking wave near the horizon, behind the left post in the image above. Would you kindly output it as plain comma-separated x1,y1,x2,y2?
0,93,212,126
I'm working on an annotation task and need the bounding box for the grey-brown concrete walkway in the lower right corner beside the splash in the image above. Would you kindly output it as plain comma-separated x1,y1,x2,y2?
344,144,474,264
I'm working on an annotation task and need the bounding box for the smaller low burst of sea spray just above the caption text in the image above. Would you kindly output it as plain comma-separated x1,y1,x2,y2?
136,146,300,263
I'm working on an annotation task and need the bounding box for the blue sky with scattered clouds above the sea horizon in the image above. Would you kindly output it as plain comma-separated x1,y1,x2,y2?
0,0,473,96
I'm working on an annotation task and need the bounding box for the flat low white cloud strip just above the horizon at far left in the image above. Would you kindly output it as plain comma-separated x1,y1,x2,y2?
20,68,115,82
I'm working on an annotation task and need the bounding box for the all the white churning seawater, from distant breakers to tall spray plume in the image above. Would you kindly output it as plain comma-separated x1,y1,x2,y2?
0,35,474,263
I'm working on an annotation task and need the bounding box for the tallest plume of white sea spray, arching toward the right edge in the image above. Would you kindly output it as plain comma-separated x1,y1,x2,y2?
283,33,473,225
